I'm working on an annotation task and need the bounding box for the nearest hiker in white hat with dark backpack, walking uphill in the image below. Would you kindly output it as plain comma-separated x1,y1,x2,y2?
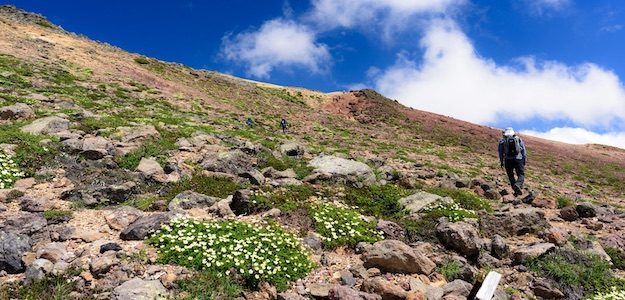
499,127,527,196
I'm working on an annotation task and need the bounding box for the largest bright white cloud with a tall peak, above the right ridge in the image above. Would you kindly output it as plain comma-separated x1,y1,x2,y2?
373,20,625,128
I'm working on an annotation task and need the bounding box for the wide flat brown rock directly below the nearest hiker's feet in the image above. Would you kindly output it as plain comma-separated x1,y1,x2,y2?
480,208,550,237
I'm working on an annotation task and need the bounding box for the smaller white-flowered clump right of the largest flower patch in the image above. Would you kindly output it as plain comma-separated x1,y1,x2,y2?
309,204,383,249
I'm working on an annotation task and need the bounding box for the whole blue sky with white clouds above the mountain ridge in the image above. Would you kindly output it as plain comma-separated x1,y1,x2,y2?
11,0,625,148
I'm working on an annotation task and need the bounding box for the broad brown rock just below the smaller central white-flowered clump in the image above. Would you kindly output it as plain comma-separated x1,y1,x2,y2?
362,240,436,275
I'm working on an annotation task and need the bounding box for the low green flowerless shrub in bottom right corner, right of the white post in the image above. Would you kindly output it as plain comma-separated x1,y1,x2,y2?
527,249,625,294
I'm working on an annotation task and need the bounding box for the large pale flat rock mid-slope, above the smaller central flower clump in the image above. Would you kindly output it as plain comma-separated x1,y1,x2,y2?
304,155,376,186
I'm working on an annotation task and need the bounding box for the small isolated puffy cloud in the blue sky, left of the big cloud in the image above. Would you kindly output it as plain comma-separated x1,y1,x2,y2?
221,19,331,78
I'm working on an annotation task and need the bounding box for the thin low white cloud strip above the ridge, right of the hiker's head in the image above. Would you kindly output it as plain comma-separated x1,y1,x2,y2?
521,127,625,149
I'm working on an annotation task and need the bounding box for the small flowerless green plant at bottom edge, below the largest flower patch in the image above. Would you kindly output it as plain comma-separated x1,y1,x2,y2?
176,271,243,300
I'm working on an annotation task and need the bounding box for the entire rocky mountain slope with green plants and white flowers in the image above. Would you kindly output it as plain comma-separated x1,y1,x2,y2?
0,6,625,300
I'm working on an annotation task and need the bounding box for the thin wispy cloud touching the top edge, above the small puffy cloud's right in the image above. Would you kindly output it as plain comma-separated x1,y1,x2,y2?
306,0,466,38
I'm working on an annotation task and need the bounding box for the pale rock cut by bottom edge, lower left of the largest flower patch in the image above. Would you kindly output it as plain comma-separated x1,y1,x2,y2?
113,278,167,300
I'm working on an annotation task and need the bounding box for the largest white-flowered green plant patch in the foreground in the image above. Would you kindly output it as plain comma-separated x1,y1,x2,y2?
148,217,314,289
